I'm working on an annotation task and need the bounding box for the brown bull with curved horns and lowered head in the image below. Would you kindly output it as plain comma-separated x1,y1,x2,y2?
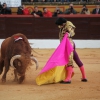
0,33,38,83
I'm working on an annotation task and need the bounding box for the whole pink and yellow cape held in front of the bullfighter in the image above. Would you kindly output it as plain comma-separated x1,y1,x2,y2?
36,33,73,85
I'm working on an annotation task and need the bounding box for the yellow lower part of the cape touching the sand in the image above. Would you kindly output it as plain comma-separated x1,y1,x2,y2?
36,66,74,85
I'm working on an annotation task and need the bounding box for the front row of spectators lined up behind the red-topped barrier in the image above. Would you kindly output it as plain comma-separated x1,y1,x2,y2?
0,3,100,17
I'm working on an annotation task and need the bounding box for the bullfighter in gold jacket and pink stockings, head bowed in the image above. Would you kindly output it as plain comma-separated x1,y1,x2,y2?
55,17,87,84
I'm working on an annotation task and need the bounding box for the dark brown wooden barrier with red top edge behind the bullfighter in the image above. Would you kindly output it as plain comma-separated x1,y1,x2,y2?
0,14,100,39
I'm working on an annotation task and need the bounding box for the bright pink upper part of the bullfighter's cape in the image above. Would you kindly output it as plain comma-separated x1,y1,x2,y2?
40,33,73,74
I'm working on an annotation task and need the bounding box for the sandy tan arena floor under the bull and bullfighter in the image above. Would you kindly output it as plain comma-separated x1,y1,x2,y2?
0,49,100,100
